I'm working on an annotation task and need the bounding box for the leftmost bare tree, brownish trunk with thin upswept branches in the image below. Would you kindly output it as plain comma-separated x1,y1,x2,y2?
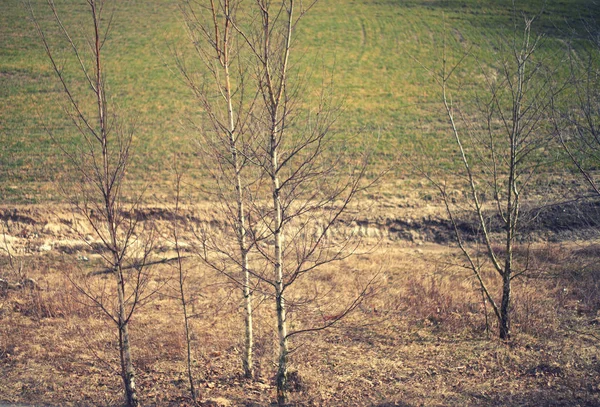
27,0,153,406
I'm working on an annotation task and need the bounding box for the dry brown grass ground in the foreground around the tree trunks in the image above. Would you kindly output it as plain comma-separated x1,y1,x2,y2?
0,199,600,406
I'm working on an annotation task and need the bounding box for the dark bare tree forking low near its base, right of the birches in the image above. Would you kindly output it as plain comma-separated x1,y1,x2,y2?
430,17,556,340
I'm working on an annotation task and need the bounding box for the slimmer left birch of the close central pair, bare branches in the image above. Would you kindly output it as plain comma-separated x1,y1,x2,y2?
177,0,257,378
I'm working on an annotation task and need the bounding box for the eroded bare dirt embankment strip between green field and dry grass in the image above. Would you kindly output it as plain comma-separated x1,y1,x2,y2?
0,201,600,255
